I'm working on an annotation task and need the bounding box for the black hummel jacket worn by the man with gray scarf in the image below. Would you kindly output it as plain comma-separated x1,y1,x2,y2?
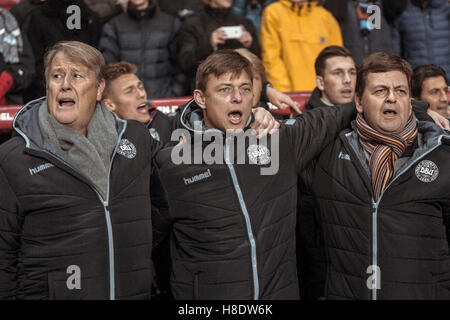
0,99,159,299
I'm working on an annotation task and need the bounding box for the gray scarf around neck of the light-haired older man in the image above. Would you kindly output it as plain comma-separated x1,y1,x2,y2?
39,101,118,199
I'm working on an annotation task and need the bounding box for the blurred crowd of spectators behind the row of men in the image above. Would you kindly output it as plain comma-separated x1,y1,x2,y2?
0,0,450,105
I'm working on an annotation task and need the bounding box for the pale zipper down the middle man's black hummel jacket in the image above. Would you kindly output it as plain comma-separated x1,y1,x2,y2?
224,137,259,300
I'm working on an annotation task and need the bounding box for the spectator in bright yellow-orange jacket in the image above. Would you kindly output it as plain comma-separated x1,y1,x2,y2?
261,0,342,92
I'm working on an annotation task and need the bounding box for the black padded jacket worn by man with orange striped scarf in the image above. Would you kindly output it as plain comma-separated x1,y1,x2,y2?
303,122,450,300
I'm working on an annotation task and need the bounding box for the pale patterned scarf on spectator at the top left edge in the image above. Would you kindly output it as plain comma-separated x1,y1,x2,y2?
0,8,23,63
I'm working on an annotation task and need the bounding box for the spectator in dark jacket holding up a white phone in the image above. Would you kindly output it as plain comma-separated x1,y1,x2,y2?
179,0,260,89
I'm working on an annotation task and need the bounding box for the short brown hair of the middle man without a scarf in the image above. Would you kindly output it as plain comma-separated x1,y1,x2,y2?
195,49,253,92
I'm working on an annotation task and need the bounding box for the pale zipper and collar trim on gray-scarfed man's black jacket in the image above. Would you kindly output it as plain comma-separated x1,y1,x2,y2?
14,117,127,300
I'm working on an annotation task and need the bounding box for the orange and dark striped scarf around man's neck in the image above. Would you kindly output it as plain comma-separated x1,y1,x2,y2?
356,113,417,200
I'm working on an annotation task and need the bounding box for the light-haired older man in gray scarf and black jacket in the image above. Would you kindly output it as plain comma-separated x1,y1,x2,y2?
0,41,159,299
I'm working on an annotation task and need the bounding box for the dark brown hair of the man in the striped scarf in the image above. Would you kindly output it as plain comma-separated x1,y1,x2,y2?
356,52,412,98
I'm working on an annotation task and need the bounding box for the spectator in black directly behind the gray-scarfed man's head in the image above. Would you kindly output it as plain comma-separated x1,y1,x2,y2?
23,0,101,102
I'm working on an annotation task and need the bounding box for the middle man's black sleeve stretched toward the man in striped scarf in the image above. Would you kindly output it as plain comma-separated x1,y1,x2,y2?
280,103,356,173
